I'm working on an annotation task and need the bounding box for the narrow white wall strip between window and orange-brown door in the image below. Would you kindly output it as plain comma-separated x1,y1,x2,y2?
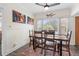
68,17,75,45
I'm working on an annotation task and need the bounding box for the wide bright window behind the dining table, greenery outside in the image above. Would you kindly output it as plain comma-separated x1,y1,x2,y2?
37,18,68,34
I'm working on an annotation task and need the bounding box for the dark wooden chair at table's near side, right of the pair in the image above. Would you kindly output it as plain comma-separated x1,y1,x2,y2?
44,30,56,55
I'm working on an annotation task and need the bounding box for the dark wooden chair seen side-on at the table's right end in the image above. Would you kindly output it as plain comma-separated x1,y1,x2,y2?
58,31,72,56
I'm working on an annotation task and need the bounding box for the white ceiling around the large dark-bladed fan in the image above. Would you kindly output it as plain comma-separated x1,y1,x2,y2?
19,3,74,14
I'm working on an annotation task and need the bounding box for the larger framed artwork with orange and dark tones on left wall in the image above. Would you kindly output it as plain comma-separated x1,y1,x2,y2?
12,10,26,23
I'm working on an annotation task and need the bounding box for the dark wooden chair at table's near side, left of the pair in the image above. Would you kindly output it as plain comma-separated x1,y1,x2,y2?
33,31,44,53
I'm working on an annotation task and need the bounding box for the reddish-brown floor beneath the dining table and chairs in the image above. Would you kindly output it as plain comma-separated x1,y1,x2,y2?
8,45,79,56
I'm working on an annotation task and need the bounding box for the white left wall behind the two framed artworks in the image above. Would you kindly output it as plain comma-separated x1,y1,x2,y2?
2,4,33,55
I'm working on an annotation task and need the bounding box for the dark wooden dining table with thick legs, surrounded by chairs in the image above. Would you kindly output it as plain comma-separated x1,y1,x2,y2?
33,30,68,56
